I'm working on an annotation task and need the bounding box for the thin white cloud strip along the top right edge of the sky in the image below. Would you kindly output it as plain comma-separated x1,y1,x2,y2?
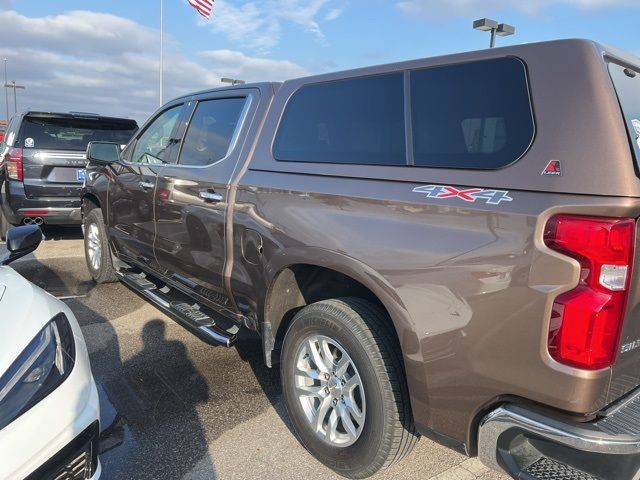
396,0,640,19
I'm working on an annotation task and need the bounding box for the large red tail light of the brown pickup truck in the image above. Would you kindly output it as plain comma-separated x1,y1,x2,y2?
544,215,635,370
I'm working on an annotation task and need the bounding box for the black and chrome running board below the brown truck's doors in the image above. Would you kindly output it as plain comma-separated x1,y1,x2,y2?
116,270,240,347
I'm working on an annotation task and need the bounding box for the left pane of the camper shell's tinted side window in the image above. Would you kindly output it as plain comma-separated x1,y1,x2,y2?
273,73,406,165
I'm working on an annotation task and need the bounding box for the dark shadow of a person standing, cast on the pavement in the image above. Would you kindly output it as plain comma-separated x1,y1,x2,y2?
101,319,215,480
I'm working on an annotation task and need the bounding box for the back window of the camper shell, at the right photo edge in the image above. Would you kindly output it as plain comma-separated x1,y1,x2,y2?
609,63,640,167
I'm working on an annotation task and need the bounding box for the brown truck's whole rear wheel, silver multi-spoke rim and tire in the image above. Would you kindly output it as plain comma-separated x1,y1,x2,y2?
281,298,418,478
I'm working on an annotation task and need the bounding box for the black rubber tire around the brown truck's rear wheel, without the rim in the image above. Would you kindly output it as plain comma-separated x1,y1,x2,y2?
280,298,419,478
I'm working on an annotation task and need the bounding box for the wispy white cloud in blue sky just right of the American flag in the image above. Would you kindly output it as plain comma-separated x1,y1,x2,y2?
210,0,341,53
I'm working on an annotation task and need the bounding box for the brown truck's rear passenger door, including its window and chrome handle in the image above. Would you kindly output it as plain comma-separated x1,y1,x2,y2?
154,88,259,312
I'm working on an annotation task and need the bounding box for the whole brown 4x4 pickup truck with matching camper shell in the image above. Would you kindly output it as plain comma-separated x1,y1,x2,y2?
83,40,640,480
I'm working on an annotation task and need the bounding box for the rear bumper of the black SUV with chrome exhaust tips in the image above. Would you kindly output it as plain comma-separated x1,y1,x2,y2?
0,181,82,225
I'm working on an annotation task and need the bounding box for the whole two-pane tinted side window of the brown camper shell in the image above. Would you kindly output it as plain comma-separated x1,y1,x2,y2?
273,57,534,169
